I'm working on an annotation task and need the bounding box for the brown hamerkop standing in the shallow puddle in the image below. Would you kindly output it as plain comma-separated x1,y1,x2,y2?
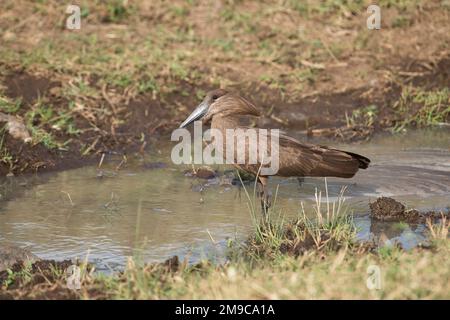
180,89,370,211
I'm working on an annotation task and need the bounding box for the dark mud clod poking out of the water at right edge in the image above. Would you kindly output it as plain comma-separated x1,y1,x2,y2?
369,197,450,223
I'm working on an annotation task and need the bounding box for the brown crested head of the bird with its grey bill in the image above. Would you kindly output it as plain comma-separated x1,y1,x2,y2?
180,89,260,128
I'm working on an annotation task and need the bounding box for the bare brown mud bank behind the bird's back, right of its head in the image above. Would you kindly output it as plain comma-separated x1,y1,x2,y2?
260,56,450,142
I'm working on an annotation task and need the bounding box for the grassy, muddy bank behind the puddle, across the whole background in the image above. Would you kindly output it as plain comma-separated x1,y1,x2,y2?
0,0,450,175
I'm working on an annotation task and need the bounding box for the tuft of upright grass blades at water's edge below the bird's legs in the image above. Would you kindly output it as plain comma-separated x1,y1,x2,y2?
237,175,356,261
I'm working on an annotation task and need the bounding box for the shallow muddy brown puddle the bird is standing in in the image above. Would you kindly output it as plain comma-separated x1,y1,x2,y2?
0,130,450,271
